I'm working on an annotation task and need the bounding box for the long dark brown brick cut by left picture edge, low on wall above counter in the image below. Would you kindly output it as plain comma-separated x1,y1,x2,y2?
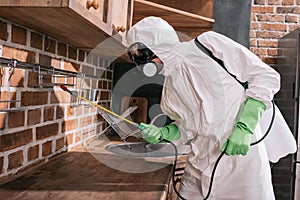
0,129,32,151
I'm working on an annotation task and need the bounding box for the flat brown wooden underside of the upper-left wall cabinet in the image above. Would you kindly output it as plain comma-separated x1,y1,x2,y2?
0,0,109,49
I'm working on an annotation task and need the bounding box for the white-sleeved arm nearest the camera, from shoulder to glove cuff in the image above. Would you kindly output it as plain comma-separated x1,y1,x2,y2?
198,31,280,109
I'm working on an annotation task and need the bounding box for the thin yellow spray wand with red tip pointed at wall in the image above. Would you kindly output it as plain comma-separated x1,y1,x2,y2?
60,85,145,130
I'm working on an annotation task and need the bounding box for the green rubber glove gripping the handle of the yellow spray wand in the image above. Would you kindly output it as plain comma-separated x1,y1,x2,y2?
140,123,181,144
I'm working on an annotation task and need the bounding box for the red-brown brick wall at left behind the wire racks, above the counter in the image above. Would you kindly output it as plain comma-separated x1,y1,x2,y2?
0,18,112,178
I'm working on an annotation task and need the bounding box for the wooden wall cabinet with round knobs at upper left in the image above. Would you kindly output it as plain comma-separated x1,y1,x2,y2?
0,0,128,50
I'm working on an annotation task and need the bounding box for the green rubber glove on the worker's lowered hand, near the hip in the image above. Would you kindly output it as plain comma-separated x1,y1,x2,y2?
221,98,266,155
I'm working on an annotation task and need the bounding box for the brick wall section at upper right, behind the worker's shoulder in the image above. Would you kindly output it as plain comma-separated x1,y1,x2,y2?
250,0,300,61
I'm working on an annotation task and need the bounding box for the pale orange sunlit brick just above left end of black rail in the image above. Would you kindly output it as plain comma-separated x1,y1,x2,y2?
2,46,35,64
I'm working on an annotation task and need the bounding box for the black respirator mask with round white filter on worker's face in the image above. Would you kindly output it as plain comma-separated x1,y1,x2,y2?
127,42,162,77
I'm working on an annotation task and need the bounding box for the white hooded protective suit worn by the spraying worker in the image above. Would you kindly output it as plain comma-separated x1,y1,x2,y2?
127,17,296,200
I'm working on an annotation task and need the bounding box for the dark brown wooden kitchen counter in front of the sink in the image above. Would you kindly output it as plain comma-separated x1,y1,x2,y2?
0,135,180,200
